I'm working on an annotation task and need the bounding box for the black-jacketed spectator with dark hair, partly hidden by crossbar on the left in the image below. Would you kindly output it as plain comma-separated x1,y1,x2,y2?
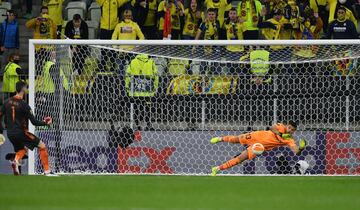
65,14,89,74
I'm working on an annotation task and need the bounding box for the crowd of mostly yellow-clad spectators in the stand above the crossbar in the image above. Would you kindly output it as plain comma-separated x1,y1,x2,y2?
19,0,360,40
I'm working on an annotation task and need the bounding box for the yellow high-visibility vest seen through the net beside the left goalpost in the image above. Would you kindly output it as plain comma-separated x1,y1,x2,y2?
37,61,69,93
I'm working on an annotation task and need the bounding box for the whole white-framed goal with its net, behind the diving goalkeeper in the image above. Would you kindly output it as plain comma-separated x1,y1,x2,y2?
29,40,360,175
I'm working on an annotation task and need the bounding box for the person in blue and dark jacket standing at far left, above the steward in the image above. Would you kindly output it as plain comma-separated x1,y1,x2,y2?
0,10,19,69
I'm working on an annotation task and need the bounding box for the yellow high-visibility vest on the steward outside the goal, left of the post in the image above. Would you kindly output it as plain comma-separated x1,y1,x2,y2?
3,62,21,93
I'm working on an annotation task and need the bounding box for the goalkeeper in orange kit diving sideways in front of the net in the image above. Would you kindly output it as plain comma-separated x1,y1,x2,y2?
210,121,306,176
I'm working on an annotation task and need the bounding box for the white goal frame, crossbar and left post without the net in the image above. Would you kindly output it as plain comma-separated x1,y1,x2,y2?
28,39,360,175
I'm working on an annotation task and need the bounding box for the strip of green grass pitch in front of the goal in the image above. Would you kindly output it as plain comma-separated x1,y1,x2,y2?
0,175,360,210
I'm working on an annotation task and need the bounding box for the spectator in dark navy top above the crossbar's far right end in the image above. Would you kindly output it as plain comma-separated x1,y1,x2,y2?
325,6,358,39
